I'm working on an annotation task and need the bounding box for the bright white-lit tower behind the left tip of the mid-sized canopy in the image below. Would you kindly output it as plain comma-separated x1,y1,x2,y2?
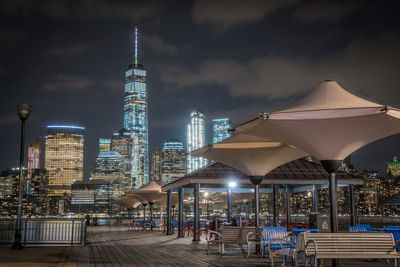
186,110,208,173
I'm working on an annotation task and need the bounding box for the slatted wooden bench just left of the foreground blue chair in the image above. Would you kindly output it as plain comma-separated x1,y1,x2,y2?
206,227,255,256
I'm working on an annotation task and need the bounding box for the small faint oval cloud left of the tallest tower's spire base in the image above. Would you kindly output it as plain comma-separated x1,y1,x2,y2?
43,74,94,92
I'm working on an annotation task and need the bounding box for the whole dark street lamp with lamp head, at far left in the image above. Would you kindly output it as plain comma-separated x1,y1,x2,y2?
11,104,31,249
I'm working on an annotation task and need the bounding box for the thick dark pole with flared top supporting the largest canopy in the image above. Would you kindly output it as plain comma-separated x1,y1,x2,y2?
321,160,342,267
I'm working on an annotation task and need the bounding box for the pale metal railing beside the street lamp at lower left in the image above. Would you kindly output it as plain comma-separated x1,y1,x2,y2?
0,219,86,246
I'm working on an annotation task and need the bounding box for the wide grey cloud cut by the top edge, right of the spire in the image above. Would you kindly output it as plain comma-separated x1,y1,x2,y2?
192,0,297,31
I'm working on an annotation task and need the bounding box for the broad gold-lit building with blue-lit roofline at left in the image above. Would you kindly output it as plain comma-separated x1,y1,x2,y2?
45,125,85,195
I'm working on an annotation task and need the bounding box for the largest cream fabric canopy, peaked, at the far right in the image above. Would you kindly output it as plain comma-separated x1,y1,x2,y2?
236,81,400,160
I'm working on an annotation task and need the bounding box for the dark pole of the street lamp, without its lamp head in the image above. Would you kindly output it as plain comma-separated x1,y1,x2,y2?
12,119,25,249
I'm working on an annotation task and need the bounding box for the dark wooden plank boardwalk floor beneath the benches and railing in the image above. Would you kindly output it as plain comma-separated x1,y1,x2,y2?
0,227,393,267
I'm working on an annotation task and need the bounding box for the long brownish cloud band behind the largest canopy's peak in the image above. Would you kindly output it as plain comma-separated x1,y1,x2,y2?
160,33,400,104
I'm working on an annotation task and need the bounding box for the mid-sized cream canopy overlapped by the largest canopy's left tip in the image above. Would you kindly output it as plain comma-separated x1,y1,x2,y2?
191,134,307,176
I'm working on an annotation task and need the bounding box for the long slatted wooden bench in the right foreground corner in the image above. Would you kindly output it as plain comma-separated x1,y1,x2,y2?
302,232,400,266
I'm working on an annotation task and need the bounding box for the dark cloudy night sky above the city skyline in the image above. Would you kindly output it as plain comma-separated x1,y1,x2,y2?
0,0,400,177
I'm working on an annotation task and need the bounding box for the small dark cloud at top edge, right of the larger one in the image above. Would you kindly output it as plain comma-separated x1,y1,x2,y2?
294,1,362,23
